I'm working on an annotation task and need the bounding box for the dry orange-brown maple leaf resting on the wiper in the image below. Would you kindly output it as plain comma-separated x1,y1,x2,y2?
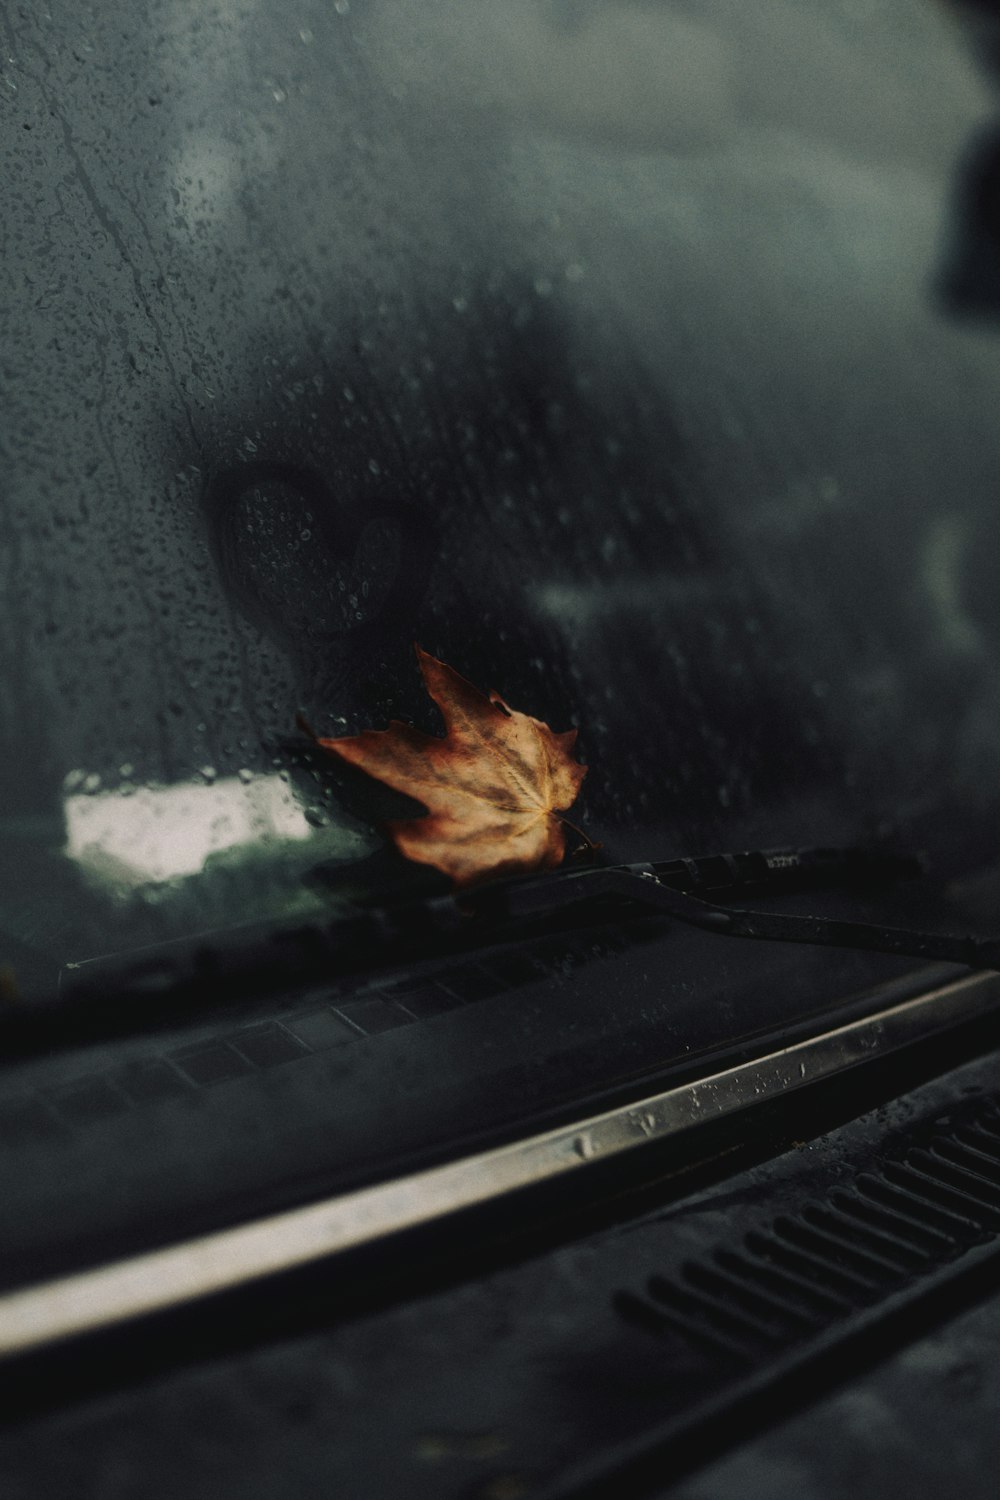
316,647,586,885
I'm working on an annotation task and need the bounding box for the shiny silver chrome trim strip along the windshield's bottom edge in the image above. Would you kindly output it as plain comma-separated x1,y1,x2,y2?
0,972,1000,1359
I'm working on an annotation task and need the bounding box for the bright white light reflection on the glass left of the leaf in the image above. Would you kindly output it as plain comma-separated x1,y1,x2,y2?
64,776,312,885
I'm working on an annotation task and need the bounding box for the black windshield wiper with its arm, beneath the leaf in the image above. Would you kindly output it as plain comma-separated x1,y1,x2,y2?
0,849,983,1059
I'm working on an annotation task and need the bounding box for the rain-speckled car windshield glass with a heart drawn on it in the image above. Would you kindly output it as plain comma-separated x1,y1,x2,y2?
0,0,1000,1274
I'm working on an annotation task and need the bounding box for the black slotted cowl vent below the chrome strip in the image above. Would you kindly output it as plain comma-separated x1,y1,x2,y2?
615,1098,1000,1367
